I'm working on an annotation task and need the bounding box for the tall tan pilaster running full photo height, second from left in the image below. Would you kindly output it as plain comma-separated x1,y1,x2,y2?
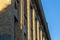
27,0,31,40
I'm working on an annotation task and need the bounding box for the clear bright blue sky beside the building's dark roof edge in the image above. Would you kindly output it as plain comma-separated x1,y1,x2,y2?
42,0,60,40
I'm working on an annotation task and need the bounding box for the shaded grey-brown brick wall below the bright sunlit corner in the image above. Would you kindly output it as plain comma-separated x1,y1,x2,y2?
0,6,13,35
